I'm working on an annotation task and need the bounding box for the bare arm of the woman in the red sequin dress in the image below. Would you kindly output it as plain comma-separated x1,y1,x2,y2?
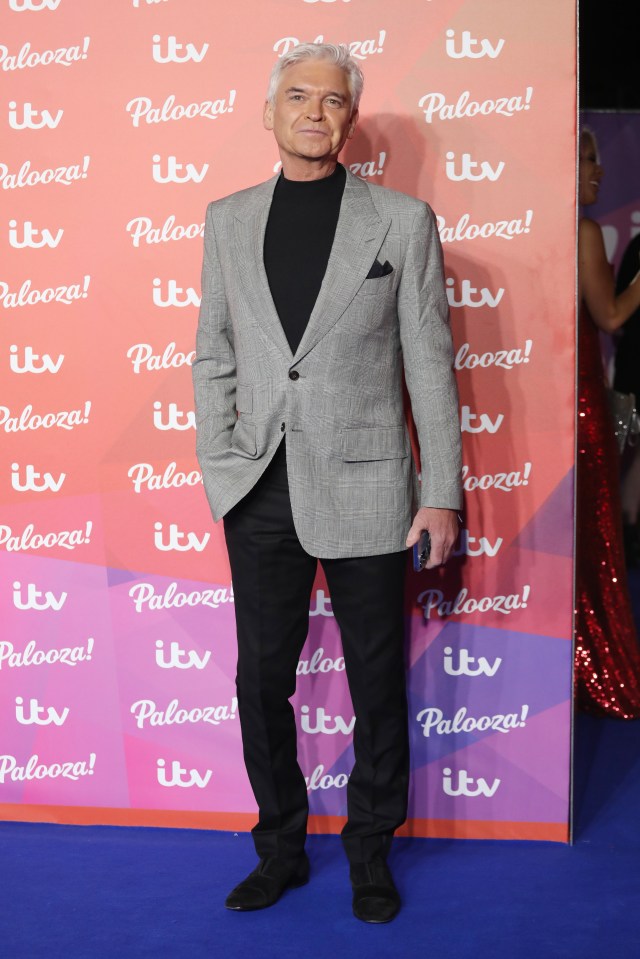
578,218,640,333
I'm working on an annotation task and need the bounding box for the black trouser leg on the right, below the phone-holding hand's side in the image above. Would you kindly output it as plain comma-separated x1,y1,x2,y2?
321,552,409,862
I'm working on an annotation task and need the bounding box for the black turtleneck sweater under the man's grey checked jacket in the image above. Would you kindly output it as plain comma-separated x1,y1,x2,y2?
264,164,347,353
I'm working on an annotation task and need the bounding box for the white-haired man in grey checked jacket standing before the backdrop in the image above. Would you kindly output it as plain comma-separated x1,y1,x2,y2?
193,44,460,922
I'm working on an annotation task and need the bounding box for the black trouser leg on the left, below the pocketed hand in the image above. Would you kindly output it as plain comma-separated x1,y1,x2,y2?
224,449,317,858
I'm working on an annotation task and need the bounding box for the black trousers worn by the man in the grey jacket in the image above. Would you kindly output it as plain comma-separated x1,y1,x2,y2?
224,441,409,862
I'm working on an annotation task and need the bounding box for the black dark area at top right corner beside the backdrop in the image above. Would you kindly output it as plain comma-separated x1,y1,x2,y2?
579,0,640,110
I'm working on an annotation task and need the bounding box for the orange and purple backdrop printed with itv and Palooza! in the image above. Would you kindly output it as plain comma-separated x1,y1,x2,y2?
0,0,576,841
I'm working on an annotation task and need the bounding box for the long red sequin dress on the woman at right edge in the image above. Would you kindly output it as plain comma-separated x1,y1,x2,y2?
575,306,640,719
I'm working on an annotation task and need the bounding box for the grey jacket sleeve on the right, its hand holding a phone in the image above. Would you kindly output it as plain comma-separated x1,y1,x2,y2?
398,203,462,509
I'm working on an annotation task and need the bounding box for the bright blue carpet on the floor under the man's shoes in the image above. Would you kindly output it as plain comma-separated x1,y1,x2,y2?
0,716,640,959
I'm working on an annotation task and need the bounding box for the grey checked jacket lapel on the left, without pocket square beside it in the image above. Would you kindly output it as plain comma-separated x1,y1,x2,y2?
235,176,293,363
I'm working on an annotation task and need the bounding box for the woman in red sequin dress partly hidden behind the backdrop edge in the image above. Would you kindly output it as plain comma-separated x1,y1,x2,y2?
575,130,640,719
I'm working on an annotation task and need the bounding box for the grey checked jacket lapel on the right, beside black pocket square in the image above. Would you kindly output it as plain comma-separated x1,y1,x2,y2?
295,170,391,361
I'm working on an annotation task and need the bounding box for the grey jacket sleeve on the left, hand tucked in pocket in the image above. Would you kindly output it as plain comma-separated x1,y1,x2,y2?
193,203,237,472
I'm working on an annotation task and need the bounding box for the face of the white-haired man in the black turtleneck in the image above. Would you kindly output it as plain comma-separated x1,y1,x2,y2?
264,60,358,163
